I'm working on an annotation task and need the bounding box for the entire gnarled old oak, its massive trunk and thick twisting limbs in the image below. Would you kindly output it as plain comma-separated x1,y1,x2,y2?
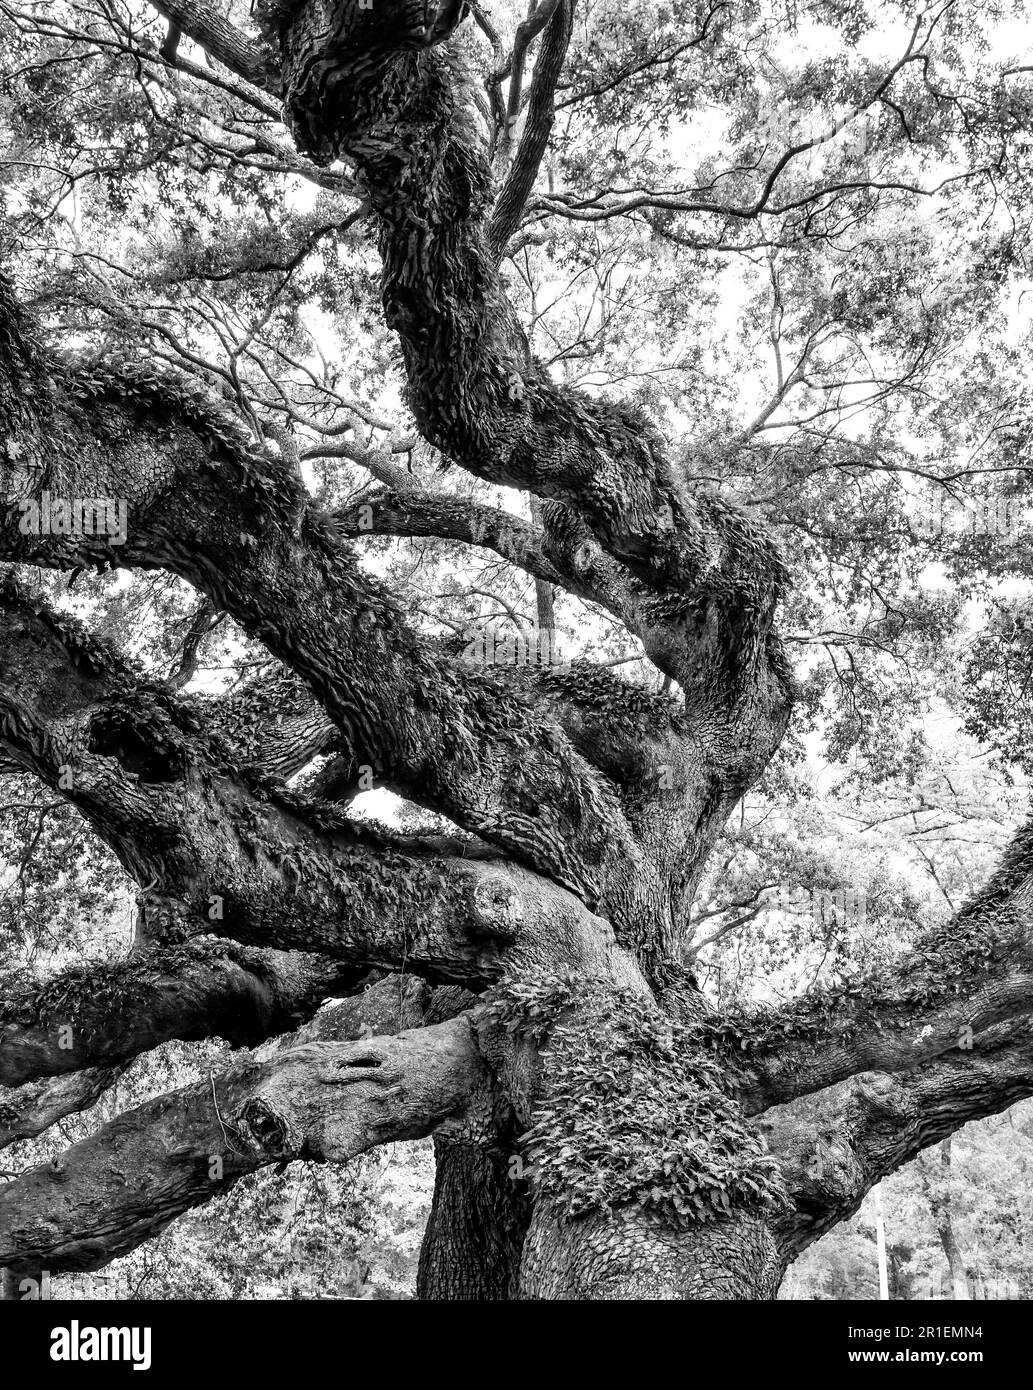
0,0,1033,1300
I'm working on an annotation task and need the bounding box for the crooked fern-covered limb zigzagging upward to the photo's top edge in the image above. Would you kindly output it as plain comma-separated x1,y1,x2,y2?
259,0,783,728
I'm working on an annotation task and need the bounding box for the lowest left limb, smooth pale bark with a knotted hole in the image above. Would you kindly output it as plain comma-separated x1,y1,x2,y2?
0,983,487,1273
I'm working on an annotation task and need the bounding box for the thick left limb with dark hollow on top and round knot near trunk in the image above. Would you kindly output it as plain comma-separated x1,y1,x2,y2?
0,578,631,988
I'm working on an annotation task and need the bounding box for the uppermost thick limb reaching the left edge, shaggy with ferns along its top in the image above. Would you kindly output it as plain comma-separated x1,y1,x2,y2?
0,329,650,924
